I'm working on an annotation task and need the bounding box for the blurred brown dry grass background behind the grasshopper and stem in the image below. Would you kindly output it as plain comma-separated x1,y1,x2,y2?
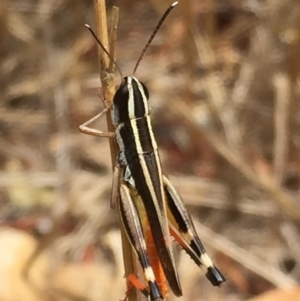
0,0,300,301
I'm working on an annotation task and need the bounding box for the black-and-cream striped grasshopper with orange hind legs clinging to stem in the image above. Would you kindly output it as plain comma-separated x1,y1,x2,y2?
79,2,225,300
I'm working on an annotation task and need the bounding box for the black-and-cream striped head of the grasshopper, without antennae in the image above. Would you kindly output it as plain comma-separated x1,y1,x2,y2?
112,76,150,126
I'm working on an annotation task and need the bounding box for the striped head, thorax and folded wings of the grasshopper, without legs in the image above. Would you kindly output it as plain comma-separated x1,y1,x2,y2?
112,76,181,296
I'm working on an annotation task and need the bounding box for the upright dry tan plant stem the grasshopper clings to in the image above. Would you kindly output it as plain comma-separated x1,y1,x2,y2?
94,0,137,301
